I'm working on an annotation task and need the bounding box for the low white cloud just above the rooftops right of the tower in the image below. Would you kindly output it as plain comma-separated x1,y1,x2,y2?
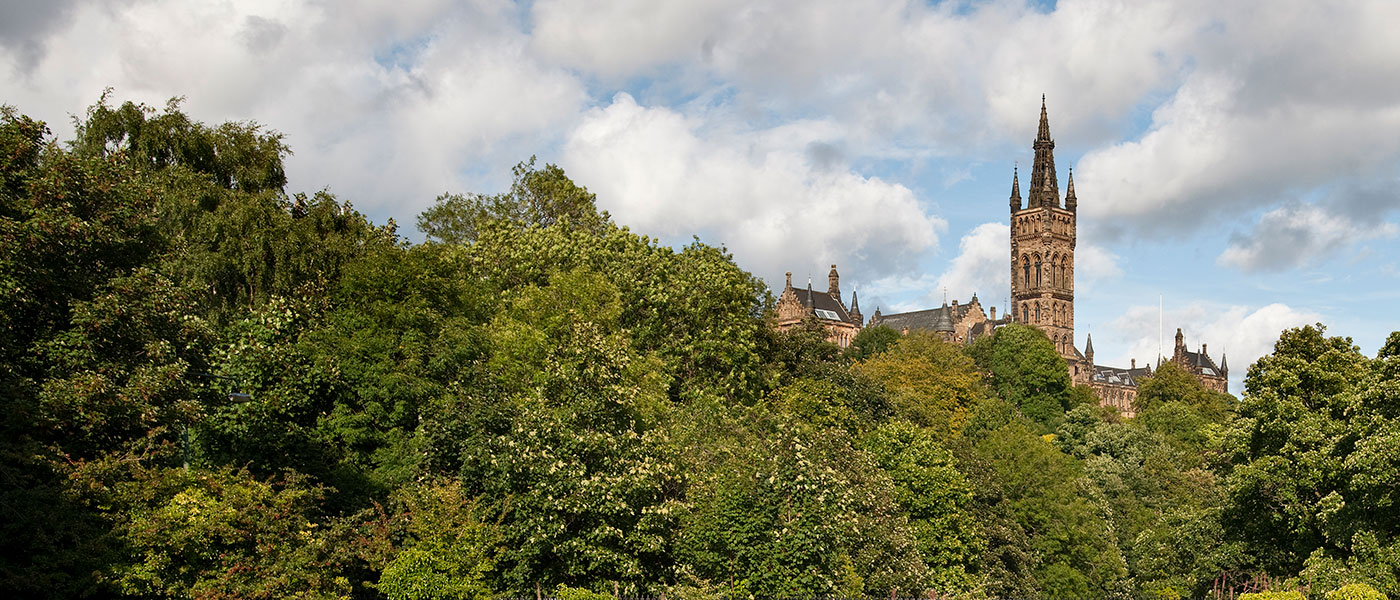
1095,302,1323,394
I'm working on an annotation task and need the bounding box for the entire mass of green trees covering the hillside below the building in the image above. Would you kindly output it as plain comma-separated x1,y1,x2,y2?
10,94,1400,600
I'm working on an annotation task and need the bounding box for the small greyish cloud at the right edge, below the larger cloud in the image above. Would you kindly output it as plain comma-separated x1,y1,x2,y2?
1217,204,1397,271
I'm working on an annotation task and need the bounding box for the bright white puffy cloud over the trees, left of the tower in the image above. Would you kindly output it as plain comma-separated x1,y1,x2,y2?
561,94,946,288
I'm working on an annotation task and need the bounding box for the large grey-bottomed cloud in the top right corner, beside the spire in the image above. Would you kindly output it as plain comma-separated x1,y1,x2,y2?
1077,3,1400,235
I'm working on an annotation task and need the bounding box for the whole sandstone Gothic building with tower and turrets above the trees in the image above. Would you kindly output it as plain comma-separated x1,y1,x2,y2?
777,97,1229,417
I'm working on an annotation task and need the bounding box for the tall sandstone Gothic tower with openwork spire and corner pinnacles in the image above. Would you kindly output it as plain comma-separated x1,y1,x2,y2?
1011,95,1085,363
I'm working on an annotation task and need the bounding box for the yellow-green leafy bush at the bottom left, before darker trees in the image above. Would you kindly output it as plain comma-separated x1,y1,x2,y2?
109,469,350,599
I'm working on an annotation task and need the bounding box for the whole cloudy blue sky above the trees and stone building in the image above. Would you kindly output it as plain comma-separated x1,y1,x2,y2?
0,0,1400,393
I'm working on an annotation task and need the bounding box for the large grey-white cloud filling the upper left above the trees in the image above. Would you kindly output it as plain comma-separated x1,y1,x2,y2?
0,1,587,221
